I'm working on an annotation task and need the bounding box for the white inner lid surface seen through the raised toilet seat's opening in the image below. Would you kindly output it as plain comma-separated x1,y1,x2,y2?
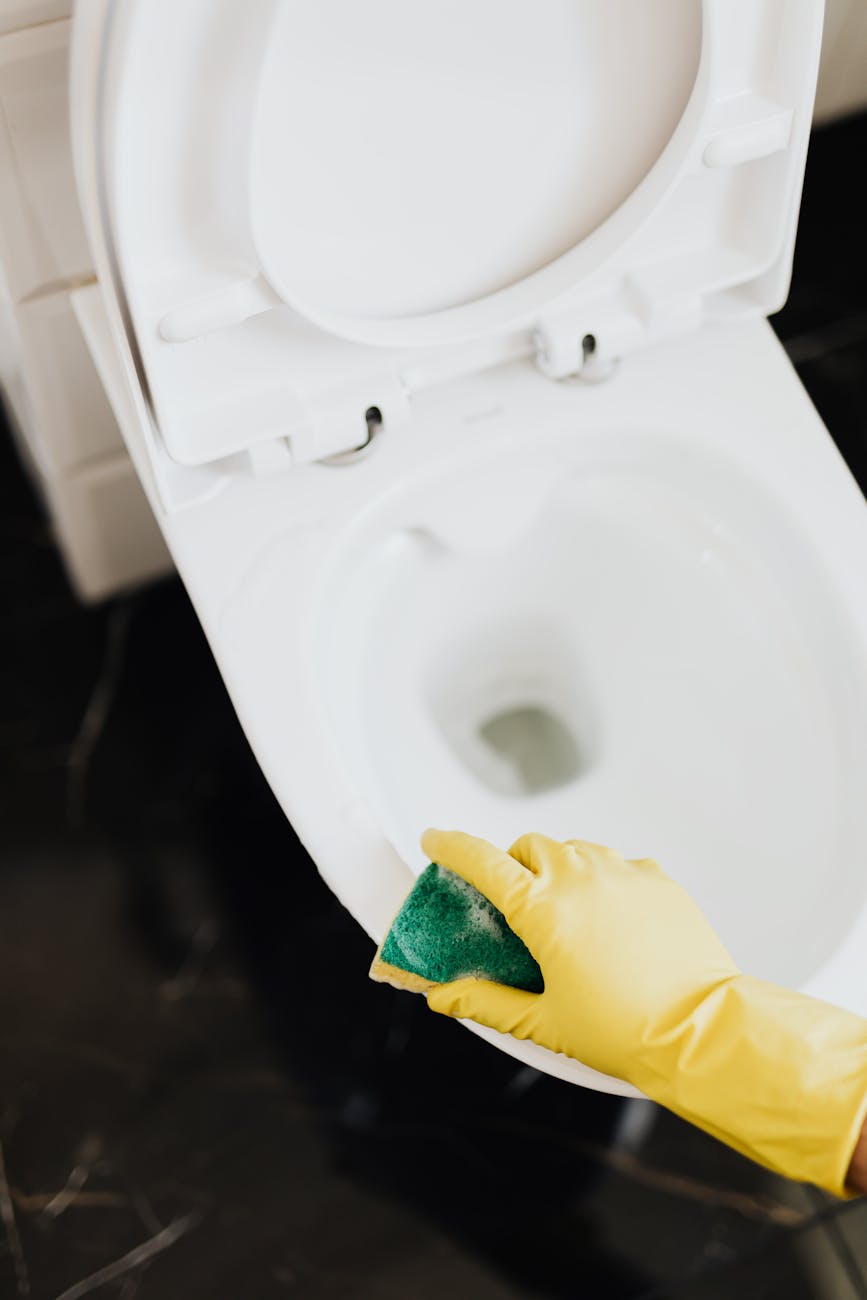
250,0,701,333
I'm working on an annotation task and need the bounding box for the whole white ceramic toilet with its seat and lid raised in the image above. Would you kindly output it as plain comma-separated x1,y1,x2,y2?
10,0,867,1095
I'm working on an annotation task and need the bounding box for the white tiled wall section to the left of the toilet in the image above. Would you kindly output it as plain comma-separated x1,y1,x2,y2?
0,17,170,599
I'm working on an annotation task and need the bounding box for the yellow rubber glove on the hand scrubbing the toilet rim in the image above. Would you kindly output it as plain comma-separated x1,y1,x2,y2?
422,831,867,1196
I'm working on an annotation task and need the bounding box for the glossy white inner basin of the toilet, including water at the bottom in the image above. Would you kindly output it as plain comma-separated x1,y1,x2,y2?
320,433,867,985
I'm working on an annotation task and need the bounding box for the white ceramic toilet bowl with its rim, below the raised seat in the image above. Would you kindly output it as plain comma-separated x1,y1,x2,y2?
178,324,867,1091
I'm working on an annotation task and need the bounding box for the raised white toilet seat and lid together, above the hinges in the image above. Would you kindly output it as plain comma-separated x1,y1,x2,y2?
73,0,823,478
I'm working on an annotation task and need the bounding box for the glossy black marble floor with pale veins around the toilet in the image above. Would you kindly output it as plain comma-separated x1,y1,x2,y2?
0,120,867,1300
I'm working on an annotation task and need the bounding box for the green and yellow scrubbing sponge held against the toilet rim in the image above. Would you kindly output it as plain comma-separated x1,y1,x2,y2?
370,862,545,993
